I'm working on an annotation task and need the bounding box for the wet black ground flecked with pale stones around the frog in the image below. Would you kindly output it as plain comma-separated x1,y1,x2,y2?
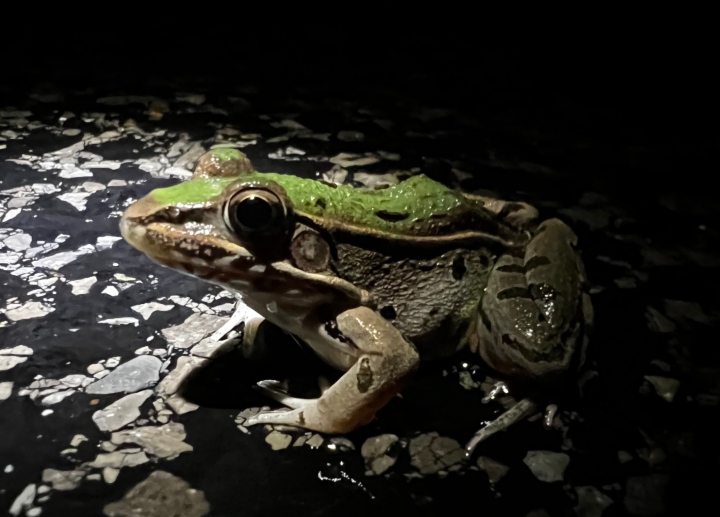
0,41,720,517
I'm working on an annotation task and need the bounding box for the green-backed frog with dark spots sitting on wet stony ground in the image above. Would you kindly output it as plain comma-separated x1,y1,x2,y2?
120,147,593,452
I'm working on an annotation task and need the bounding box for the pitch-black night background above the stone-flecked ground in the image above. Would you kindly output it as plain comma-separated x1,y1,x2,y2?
5,23,718,217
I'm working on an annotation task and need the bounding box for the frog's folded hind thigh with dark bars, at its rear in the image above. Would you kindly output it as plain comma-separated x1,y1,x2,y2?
478,219,584,376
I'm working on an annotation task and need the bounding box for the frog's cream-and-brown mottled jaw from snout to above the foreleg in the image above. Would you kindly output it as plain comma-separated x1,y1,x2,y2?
120,218,373,306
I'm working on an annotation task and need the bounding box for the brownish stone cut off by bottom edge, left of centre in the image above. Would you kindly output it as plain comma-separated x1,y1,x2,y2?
103,470,210,517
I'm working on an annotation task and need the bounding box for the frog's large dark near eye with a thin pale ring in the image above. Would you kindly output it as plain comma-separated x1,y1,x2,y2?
224,188,287,236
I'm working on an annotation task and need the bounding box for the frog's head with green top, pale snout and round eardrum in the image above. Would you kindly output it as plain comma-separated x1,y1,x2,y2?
120,149,368,312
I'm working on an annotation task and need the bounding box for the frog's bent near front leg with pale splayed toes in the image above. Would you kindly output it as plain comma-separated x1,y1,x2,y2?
245,307,420,433
